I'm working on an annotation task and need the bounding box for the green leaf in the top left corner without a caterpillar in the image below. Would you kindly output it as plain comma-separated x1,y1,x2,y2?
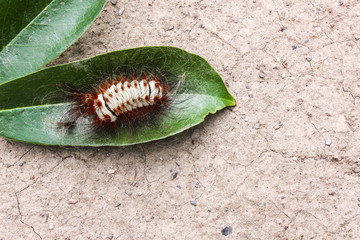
0,0,106,83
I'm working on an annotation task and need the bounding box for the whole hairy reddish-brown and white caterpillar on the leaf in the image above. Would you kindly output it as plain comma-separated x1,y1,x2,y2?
62,73,169,127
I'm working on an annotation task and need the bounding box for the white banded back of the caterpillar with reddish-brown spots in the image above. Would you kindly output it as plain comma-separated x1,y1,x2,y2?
90,79,163,122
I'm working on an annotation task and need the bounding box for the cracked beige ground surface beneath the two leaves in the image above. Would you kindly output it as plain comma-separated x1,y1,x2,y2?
0,0,360,239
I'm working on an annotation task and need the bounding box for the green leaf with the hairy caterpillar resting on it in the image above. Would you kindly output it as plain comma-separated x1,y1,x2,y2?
0,47,235,146
